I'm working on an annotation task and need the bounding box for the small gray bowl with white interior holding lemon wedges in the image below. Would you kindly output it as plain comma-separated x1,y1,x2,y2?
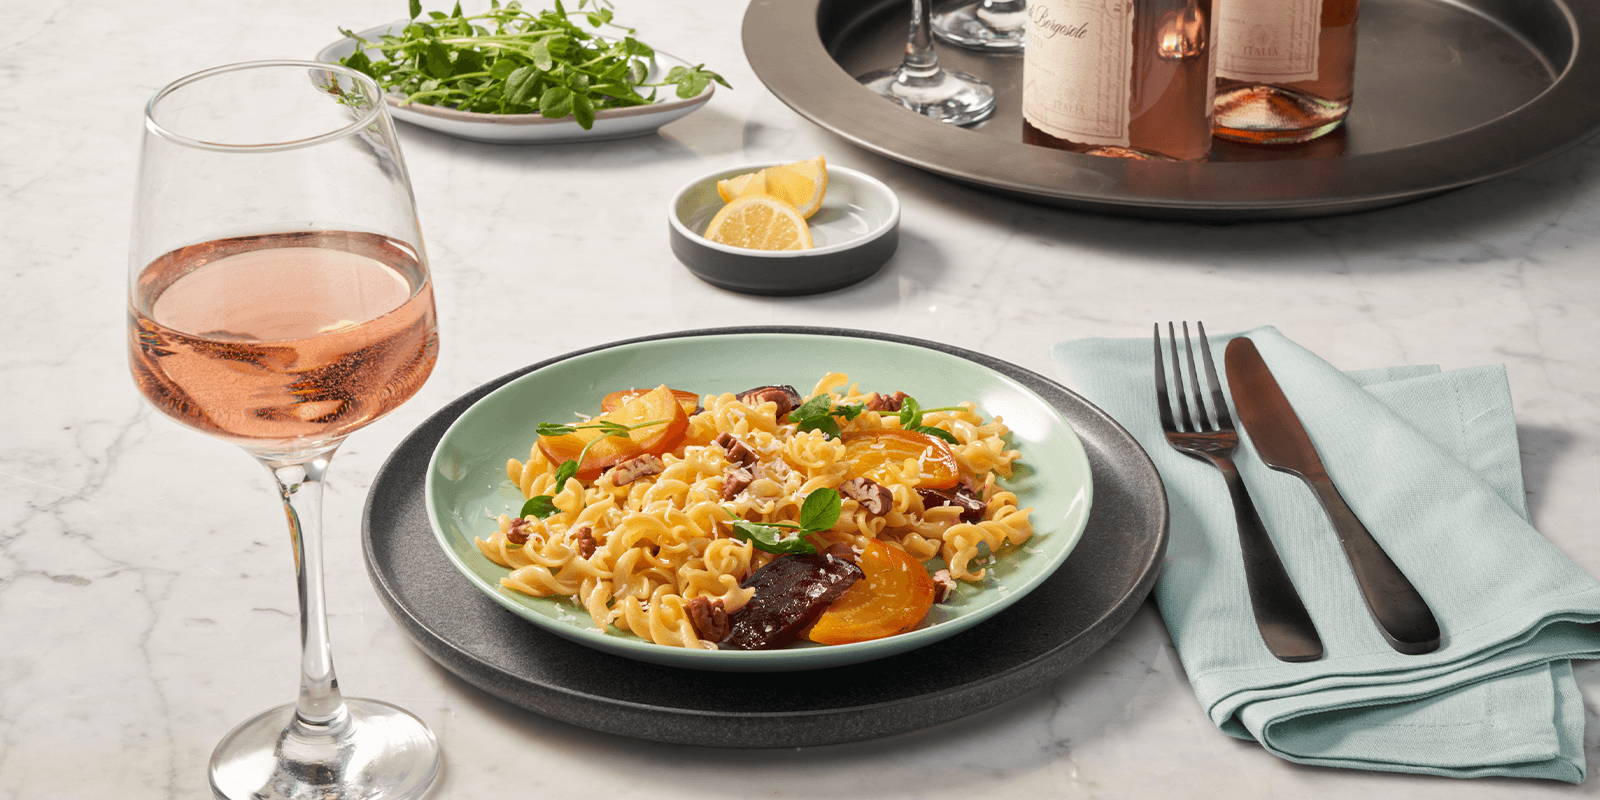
667,163,899,294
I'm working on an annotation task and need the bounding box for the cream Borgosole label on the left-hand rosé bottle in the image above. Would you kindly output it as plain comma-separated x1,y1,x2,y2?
1022,0,1133,147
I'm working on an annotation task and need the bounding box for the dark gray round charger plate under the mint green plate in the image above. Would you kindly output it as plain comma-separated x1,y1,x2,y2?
362,326,1166,747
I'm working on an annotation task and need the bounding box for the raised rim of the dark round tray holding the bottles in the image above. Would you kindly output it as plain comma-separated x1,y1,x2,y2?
742,0,1600,214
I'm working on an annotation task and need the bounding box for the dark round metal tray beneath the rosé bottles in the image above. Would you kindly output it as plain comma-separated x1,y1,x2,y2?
744,0,1600,221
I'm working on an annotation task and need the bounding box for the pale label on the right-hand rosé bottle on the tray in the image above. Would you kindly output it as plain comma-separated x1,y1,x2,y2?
1216,0,1322,83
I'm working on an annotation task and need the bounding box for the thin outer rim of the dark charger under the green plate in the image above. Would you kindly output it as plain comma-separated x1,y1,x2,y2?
362,325,1171,720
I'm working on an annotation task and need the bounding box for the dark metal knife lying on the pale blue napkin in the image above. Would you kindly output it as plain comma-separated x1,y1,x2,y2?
1224,336,1438,656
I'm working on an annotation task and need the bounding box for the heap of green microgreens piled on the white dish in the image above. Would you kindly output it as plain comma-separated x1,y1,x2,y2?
339,0,728,130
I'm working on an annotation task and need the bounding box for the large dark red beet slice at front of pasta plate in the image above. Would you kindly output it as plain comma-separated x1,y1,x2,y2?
718,554,862,650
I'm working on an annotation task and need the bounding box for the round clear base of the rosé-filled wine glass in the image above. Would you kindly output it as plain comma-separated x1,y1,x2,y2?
211,698,440,800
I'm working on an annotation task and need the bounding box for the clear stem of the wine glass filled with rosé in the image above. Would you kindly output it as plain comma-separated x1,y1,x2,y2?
259,448,347,734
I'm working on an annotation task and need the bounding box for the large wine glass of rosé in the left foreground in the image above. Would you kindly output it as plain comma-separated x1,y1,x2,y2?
128,61,438,798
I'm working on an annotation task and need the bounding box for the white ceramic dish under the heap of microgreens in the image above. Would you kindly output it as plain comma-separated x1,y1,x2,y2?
317,21,715,144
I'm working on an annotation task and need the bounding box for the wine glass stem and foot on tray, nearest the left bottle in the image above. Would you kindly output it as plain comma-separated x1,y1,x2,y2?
856,0,995,125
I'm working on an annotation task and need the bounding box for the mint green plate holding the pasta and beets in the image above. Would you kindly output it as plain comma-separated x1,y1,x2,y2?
426,333,1093,672
